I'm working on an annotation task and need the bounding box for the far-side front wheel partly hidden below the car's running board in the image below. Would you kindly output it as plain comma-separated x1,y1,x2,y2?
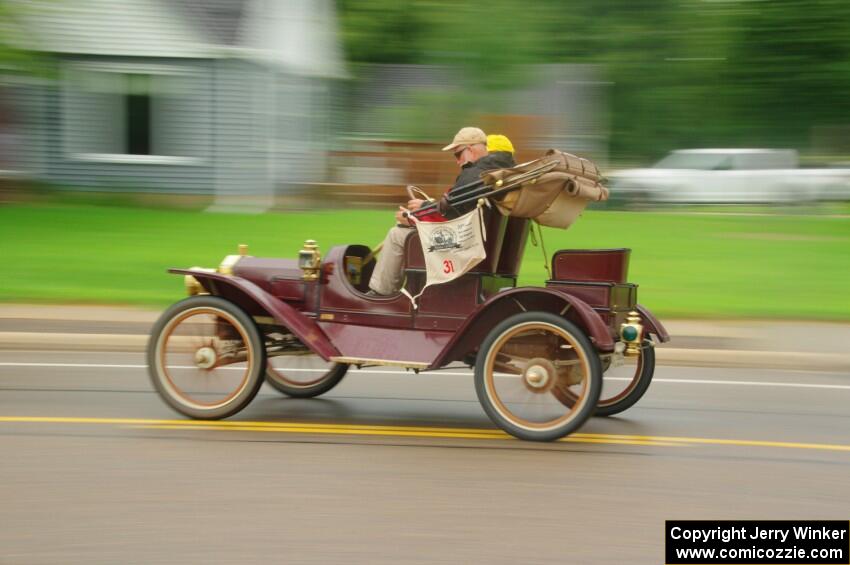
266,353,348,398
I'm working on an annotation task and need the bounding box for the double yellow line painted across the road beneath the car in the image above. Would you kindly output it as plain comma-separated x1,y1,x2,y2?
0,416,850,452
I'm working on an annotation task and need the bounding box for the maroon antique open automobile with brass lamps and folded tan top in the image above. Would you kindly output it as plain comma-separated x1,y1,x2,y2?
147,151,669,441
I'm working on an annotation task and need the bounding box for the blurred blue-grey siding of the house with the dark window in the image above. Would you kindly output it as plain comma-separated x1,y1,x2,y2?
12,57,338,195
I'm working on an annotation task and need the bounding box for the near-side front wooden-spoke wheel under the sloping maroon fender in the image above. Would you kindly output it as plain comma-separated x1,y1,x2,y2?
147,296,266,420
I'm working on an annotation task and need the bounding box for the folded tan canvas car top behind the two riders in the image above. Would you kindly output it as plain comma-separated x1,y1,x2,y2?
482,149,608,229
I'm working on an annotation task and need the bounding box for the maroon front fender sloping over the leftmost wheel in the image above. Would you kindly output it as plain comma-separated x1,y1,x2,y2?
168,269,340,361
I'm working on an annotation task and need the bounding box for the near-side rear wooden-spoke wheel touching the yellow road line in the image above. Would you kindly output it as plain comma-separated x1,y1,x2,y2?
475,312,602,441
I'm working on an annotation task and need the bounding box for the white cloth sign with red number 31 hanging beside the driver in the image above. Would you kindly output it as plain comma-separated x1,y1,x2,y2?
405,207,487,306
